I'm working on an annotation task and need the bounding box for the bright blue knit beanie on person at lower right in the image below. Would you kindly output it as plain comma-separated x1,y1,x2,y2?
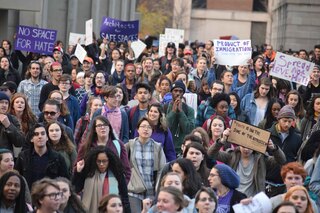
214,164,240,189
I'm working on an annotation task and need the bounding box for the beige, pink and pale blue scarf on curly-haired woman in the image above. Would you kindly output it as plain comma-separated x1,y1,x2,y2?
82,170,119,213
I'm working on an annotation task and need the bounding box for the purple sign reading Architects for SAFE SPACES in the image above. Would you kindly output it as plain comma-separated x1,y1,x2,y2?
100,17,139,42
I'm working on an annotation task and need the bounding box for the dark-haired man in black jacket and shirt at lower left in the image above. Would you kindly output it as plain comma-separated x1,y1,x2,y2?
15,124,69,188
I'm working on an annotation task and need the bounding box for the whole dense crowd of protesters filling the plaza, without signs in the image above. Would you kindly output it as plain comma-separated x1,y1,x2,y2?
0,36,320,213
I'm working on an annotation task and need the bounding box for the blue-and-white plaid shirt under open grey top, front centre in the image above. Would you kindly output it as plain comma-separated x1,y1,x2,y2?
129,140,155,200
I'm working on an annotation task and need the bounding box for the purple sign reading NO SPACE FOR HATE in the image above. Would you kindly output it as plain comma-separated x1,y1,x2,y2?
15,25,57,55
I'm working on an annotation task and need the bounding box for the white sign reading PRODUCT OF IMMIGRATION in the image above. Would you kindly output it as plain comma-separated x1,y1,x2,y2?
214,40,252,66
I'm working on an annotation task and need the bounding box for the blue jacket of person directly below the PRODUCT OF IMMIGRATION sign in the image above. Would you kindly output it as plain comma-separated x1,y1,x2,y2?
231,70,256,99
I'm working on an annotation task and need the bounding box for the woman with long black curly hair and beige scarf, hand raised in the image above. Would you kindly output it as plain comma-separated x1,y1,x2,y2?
73,146,130,213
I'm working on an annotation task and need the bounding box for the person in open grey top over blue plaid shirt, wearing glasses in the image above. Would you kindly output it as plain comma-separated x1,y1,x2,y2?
125,117,166,212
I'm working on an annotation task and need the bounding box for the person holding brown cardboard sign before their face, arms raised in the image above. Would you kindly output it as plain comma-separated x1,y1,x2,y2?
208,126,286,197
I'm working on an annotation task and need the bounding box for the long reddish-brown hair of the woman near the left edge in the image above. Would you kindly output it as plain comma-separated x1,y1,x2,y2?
9,93,37,134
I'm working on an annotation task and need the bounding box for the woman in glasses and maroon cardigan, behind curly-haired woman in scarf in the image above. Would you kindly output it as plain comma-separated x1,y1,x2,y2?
77,115,131,183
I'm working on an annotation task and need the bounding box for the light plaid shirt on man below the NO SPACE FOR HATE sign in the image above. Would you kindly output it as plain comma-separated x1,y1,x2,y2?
17,78,48,116
